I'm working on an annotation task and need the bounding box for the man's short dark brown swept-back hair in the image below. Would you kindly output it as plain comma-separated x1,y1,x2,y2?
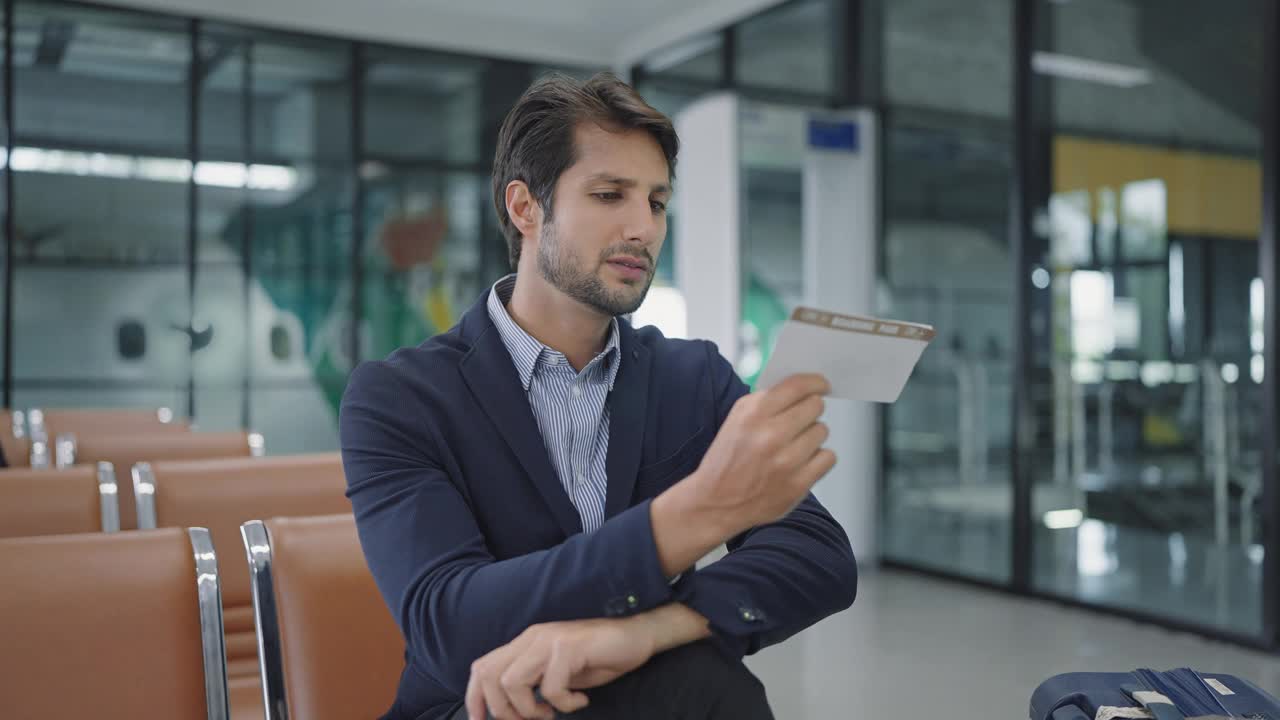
493,73,680,269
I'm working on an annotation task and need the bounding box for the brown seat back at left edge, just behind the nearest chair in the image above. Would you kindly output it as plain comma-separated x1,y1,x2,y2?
0,462,120,538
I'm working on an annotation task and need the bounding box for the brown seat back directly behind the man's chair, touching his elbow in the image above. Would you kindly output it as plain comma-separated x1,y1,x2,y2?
133,452,351,720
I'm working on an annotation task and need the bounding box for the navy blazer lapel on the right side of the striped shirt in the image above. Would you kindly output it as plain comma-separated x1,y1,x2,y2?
604,319,649,518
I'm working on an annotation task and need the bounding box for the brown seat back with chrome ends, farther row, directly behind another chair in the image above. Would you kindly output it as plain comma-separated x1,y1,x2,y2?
65,432,264,530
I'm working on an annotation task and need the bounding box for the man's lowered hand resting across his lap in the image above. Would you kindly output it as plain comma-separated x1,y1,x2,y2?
466,605,710,720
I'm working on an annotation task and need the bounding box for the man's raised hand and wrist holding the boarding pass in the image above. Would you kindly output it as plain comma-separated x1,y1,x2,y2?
650,375,836,577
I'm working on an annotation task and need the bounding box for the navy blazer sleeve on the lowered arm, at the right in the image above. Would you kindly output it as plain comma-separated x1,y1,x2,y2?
675,343,858,657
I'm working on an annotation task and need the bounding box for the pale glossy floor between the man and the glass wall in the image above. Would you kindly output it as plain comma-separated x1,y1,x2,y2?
748,570,1280,720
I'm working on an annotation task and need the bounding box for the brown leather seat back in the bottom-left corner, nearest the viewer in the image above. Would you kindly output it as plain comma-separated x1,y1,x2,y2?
0,528,227,720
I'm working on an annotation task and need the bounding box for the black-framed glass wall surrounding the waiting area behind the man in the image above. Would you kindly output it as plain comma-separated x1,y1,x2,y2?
0,0,1277,641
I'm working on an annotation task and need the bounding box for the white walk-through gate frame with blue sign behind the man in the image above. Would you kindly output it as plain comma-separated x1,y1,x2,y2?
675,94,879,570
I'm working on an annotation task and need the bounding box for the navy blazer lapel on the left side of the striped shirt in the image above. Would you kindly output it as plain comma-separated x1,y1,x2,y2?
461,297,582,536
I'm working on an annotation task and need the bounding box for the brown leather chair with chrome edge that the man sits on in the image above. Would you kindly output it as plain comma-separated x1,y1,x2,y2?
241,514,404,720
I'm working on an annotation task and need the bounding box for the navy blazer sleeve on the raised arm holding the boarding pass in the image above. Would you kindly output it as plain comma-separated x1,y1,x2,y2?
339,363,672,696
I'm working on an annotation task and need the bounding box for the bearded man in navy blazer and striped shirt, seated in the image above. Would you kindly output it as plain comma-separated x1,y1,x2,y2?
340,74,858,720
